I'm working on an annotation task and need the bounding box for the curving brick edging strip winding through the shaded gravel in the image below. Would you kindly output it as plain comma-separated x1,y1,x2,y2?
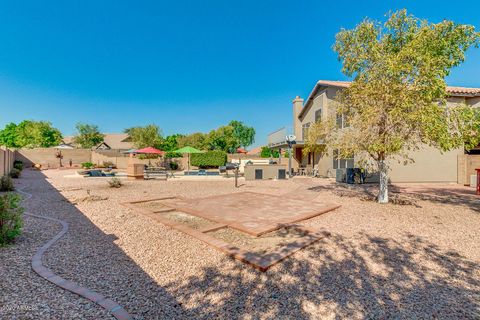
17,188,133,320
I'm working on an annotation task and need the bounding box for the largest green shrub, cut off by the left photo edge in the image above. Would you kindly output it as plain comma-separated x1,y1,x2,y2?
0,193,23,247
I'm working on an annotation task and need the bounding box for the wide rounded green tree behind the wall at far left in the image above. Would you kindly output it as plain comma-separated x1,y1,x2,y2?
15,120,62,148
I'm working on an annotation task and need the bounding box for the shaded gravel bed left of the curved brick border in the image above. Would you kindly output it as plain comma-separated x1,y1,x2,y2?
0,184,114,320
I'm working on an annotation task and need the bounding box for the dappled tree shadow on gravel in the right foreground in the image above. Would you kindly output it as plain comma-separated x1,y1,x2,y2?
167,234,480,319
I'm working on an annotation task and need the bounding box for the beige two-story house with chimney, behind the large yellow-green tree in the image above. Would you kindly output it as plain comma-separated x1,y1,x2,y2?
268,80,480,183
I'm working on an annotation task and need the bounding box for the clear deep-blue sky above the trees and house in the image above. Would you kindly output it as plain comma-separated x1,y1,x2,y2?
0,0,480,145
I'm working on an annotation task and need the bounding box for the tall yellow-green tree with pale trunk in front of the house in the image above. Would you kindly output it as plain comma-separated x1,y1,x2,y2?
307,10,480,203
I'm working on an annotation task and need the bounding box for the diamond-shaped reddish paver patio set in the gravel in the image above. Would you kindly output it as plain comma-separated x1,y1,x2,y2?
123,192,340,271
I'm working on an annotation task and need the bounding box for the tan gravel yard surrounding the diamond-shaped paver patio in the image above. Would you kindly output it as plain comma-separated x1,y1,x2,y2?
0,170,480,319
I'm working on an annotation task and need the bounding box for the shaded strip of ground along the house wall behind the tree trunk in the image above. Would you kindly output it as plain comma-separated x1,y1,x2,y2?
308,183,480,213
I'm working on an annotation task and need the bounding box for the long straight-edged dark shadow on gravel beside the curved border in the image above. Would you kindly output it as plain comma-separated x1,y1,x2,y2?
21,170,183,319
